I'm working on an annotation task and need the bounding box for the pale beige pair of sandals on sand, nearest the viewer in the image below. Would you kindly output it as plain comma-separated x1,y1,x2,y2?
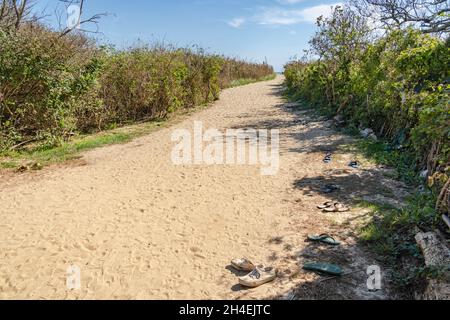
231,258,277,288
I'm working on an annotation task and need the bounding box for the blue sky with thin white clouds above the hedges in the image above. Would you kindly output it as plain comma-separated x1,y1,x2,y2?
35,0,339,71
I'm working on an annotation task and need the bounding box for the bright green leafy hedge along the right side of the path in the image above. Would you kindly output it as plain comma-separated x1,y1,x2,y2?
285,9,450,212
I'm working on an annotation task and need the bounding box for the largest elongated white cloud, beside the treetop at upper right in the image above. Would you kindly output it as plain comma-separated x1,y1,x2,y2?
255,0,342,25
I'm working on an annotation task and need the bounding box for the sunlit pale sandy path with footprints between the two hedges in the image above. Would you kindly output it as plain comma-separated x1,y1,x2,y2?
0,77,400,299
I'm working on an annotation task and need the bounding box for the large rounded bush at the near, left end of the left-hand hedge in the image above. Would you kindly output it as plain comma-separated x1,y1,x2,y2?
0,26,100,148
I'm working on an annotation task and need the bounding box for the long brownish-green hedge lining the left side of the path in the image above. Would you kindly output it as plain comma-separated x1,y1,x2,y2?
0,24,273,151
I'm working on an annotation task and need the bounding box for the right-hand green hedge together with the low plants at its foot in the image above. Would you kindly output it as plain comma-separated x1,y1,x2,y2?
285,8,450,287
